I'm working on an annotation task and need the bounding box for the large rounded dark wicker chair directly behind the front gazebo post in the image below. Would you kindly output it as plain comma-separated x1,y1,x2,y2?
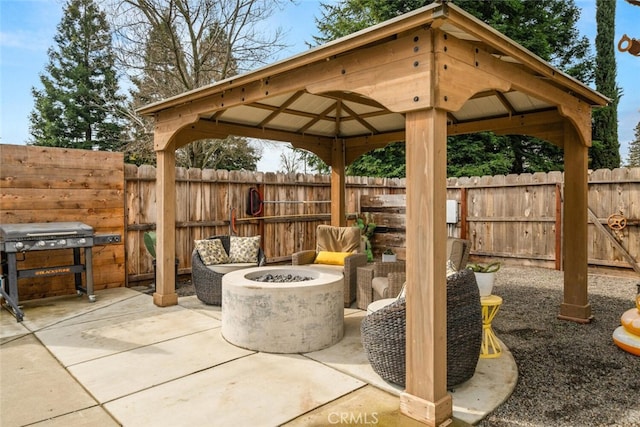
361,269,482,389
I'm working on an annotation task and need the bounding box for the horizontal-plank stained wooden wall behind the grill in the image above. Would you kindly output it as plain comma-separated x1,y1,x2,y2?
0,144,125,300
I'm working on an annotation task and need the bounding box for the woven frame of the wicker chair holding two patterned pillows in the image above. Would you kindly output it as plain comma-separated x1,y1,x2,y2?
191,235,267,305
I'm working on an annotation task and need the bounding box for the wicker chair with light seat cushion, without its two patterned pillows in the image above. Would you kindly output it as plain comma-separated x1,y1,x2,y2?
191,235,266,305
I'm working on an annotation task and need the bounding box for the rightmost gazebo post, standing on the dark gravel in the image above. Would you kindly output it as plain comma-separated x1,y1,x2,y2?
558,121,593,323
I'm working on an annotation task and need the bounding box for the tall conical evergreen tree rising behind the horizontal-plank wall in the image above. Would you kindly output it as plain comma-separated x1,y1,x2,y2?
30,0,123,151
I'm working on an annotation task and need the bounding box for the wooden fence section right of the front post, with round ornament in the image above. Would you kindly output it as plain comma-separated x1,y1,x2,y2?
449,168,640,274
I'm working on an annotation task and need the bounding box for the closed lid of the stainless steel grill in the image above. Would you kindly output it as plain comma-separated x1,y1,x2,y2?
0,222,93,242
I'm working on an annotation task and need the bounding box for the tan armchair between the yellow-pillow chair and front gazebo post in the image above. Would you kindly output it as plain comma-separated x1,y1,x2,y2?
356,261,405,310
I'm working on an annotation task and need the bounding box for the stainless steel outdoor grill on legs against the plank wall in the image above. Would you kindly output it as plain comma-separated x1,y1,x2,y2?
0,222,95,322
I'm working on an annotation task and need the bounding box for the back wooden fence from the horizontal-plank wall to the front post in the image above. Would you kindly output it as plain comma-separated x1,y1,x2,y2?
125,165,405,281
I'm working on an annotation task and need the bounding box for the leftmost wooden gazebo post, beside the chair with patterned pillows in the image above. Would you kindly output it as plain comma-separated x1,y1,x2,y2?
153,146,178,307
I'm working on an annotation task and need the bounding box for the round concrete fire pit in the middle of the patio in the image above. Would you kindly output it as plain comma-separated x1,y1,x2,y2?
222,266,344,353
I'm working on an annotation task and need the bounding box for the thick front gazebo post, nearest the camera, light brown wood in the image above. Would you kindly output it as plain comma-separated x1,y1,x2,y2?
400,108,453,426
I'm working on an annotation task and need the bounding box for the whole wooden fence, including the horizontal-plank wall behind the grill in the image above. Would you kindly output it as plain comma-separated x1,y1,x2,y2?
0,145,640,299
